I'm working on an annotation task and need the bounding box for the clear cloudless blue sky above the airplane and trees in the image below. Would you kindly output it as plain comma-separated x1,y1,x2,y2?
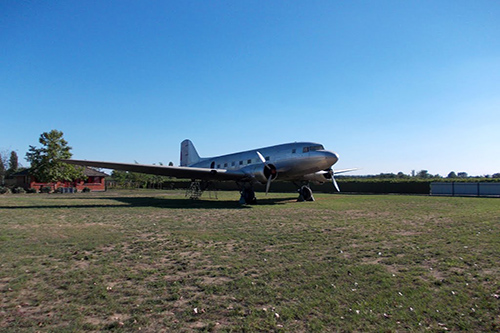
0,0,500,176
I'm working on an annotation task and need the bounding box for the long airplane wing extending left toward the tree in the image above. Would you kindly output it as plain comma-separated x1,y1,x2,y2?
61,159,250,180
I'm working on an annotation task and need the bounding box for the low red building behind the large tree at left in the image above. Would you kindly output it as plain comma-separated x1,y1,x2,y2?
12,167,108,191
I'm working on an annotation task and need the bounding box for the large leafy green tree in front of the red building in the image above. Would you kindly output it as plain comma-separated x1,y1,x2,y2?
26,130,83,182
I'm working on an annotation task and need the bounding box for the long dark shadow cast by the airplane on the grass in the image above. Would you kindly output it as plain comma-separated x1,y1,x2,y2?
0,197,295,209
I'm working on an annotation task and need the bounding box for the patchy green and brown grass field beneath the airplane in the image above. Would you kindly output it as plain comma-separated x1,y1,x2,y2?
0,191,500,332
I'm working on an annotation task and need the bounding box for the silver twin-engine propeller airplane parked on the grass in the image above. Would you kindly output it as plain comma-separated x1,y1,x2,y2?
62,140,357,204
